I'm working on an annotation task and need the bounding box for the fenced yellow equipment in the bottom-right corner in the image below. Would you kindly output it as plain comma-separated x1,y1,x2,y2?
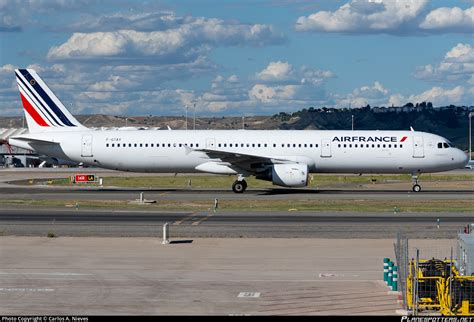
394,234,474,315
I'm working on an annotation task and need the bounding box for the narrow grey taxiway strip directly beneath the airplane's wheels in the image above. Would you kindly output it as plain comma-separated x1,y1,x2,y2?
0,186,474,200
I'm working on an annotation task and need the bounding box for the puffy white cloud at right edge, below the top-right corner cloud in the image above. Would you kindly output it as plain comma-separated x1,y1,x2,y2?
414,43,474,84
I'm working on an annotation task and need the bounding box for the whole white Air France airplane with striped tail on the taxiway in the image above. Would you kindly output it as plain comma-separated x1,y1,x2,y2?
9,69,468,193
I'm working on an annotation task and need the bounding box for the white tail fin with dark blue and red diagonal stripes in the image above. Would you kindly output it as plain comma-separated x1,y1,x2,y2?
15,69,86,133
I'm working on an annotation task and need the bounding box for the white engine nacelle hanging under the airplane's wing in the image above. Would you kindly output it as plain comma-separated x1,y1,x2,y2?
256,163,308,187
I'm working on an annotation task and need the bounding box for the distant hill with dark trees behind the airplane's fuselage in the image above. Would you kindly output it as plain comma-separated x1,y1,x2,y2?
0,103,474,150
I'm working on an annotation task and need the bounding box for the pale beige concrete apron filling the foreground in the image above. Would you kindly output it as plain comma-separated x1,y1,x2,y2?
0,237,453,315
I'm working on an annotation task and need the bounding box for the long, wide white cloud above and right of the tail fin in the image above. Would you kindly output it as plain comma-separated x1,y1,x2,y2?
47,17,285,62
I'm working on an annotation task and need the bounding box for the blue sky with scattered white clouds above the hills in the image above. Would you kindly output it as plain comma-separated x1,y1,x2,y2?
0,0,474,116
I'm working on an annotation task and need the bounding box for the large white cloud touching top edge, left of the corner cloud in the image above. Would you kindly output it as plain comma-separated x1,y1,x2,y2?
295,0,428,33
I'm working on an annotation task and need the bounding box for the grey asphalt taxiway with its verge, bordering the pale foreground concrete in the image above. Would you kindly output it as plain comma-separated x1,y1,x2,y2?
0,206,473,239
